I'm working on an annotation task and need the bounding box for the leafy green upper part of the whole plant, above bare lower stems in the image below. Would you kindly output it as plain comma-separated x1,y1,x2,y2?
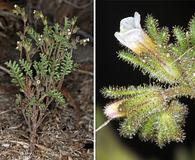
5,6,79,115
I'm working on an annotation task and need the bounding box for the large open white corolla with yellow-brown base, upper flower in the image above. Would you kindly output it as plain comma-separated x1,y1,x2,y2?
114,12,156,54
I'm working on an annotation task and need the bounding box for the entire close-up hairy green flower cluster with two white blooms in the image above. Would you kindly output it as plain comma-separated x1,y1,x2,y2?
102,12,195,147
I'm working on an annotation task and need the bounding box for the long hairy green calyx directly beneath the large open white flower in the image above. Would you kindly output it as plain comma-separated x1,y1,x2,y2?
118,51,180,84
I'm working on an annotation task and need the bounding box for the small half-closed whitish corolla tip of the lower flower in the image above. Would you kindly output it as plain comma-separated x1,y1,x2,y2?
104,100,126,119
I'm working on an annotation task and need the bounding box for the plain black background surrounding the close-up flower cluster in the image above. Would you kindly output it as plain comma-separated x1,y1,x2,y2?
96,0,195,160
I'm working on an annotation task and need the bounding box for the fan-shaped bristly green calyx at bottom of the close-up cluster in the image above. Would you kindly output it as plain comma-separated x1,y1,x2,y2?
139,101,187,147
